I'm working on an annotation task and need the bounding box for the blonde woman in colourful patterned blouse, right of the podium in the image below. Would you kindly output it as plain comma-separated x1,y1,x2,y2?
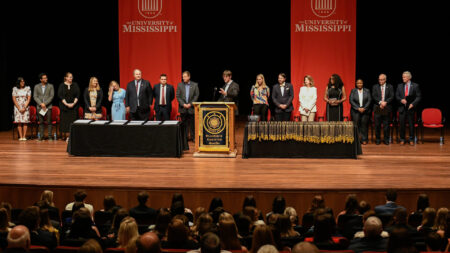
250,74,270,121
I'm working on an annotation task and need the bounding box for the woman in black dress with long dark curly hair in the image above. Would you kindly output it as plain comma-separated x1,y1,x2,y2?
324,74,347,121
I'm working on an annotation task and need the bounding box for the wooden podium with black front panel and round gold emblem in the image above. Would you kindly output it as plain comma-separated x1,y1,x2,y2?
193,102,237,158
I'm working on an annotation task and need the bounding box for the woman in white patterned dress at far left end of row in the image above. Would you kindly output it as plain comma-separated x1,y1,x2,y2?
12,77,31,141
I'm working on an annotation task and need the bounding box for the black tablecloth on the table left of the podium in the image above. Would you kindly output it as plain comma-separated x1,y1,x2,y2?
67,123,188,157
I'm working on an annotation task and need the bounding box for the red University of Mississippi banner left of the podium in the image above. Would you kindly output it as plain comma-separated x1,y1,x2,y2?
119,0,182,118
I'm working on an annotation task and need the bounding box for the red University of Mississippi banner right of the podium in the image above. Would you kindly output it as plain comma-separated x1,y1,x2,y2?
291,0,356,119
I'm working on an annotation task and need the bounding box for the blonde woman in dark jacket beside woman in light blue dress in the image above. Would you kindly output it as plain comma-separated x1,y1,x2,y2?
83,77,103,120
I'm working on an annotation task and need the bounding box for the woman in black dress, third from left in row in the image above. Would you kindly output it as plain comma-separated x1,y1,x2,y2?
58,72,80,141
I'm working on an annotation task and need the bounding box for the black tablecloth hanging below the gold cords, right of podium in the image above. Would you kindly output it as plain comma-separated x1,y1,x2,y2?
242,122,362,159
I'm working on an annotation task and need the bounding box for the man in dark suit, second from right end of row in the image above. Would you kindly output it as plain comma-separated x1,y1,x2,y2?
372,74,394,145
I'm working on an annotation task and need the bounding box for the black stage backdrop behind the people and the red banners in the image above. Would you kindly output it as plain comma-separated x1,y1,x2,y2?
0,0,450,130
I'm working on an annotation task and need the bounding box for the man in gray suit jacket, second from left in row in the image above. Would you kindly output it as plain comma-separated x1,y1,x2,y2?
33,73,55,141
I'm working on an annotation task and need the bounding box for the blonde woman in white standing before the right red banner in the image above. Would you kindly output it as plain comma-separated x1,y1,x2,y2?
298,75,317,121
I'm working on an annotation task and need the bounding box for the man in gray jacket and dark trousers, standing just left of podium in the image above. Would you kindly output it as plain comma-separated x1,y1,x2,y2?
176,71,200,140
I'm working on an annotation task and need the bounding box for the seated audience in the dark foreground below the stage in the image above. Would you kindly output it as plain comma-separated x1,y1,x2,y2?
0,190,450,253
